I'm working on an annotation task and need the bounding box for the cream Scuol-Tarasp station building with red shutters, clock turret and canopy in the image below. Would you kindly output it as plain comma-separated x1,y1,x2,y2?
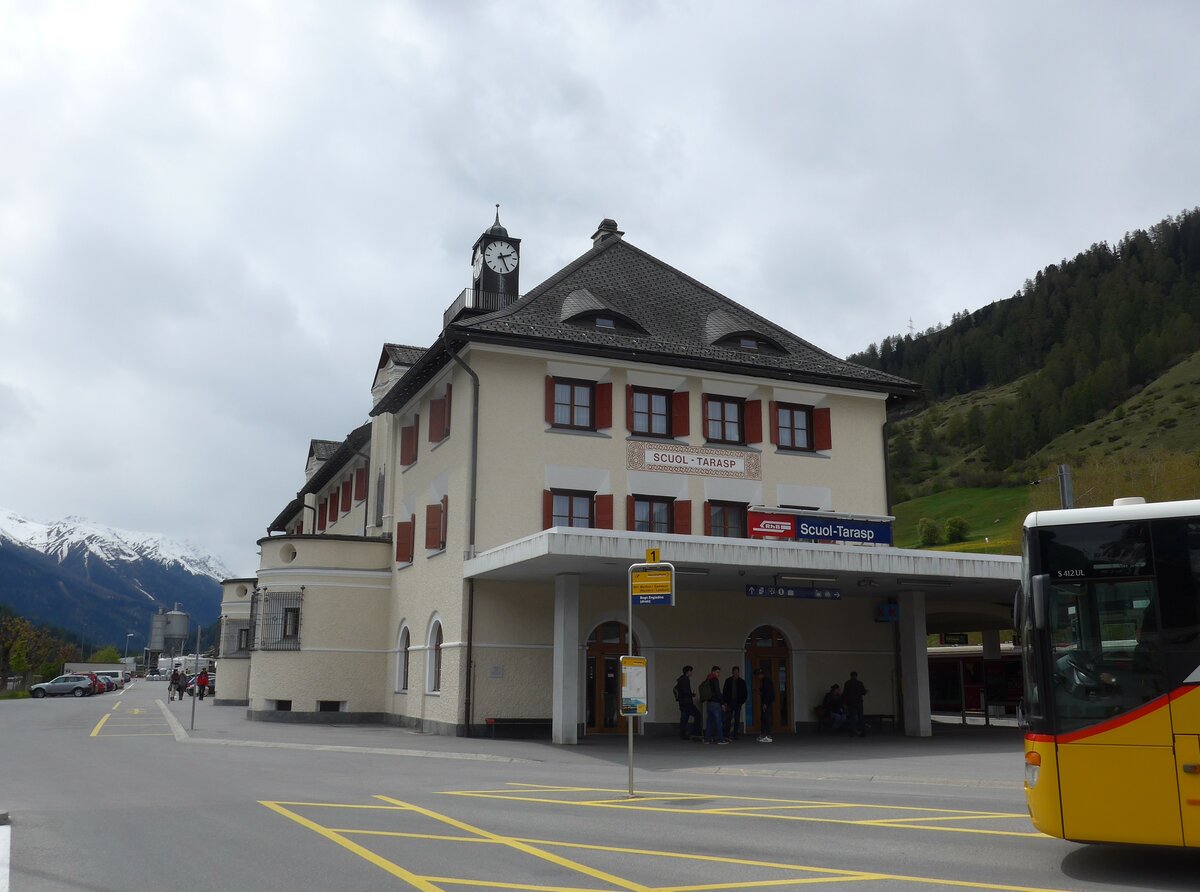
217,215,1019,743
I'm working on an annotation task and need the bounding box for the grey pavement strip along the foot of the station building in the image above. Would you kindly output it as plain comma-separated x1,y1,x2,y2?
164,701,1024,789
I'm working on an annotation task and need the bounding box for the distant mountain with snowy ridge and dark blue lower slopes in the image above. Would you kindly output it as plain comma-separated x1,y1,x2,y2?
0,509,232,647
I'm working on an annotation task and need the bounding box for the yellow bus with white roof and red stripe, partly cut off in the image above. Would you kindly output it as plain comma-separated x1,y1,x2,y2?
1014,498,1200,848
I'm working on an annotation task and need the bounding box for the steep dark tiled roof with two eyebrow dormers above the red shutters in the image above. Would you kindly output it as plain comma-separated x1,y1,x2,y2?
448,238,919,395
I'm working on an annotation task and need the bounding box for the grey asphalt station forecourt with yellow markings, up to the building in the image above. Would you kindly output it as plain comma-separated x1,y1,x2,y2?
0,681,1200,892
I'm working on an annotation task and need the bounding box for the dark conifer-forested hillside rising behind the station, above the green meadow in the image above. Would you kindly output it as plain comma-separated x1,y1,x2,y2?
850,209,1200,482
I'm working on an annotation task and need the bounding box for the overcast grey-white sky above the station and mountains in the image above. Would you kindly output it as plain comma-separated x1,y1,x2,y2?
0,0,1200,575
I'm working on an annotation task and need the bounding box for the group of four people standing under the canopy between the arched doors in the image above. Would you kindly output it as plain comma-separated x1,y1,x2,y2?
674,666,775,746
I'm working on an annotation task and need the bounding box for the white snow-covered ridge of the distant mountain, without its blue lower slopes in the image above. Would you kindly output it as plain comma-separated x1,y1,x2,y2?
0,508,233,581
